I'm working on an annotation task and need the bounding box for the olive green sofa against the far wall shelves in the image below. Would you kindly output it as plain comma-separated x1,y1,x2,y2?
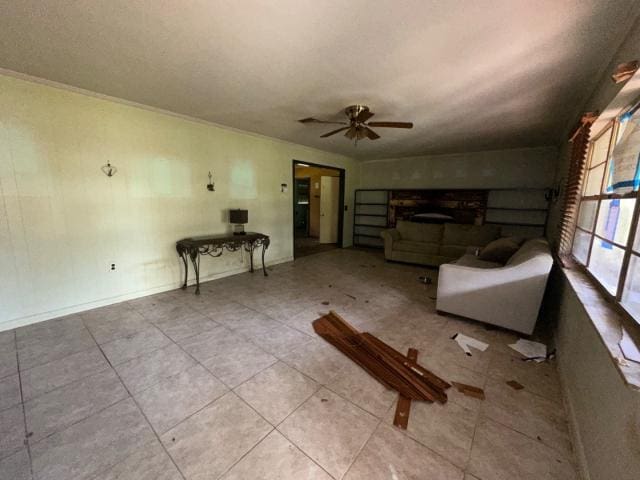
380,220,500,267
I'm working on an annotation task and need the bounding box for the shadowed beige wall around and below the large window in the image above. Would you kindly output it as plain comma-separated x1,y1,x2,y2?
545,15,640,480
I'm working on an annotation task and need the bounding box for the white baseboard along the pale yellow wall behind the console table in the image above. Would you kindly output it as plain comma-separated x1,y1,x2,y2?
0,257,293,332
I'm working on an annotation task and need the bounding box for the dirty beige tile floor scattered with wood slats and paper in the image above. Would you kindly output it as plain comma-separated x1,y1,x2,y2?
0,250,577,480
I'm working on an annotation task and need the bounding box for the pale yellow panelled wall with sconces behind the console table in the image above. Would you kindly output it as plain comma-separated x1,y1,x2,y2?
0,76,357,330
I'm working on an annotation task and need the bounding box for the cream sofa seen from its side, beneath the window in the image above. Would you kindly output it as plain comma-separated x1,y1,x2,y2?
436,238,553,335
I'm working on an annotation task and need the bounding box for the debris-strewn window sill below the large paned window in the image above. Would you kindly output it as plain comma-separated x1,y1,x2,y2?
561,268,640,392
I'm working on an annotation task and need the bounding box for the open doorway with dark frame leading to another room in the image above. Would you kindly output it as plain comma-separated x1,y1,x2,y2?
293,160,345,258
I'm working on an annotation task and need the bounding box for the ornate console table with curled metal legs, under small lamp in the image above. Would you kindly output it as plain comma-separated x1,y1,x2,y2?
176,232,270,295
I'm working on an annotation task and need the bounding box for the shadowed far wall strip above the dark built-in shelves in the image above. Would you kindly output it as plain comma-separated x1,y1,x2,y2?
360,147,558,188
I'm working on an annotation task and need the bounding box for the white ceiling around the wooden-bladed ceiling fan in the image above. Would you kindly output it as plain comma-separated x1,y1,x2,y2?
0,0,640,158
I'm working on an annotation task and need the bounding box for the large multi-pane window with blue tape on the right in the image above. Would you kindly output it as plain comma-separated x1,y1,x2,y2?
571,105,640,323
